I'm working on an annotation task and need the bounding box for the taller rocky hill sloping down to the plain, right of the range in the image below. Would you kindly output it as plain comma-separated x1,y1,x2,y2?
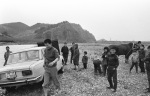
35,22,96,42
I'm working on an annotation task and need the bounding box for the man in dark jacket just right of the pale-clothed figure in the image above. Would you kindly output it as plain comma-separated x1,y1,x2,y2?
139,45,145,73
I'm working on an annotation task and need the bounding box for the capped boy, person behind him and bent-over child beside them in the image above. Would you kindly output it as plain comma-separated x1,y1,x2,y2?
93,47,119,92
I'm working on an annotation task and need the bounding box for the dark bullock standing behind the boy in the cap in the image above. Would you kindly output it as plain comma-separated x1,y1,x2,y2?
108,43,134,63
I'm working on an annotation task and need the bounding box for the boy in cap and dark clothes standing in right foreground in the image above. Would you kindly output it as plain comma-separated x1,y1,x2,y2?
107,47,119,92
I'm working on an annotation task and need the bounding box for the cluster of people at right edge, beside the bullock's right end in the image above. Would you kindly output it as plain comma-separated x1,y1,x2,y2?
130,41,150,92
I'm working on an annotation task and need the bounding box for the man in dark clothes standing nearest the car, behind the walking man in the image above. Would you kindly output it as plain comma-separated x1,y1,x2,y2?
61,42,69,65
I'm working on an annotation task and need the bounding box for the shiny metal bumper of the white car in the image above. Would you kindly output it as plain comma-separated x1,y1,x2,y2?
0,76,43,87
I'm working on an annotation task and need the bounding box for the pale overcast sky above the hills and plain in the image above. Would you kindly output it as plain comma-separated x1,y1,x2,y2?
0,0,150,41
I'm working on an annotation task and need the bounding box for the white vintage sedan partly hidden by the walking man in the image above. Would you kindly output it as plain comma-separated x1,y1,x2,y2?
0,47,63,88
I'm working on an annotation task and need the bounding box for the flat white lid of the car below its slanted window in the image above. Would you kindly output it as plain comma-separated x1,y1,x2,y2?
0,60,38,72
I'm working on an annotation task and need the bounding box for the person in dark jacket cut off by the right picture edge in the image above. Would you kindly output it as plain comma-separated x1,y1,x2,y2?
144,46,150,92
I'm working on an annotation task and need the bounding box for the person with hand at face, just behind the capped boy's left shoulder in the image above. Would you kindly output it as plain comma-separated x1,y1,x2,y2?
102,47,109,76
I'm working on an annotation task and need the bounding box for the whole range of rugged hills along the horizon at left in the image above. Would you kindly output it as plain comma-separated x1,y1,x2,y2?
0,21,96,43
